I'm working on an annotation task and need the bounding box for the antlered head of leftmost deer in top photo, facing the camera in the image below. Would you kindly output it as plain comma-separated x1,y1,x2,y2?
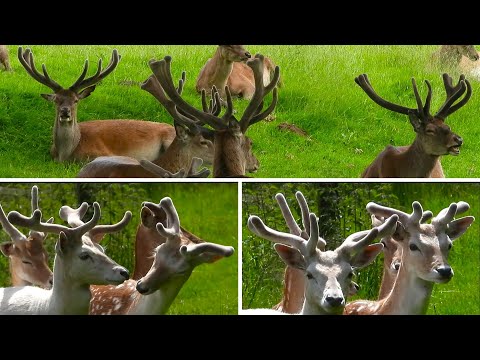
18,47,120,126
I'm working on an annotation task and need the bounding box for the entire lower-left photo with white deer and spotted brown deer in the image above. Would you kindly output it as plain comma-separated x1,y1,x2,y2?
0,182,238,315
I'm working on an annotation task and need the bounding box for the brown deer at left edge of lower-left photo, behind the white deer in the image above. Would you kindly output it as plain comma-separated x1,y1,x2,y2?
0,185,53,289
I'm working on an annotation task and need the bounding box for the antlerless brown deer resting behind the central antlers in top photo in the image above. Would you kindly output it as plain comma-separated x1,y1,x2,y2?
196,45,275,100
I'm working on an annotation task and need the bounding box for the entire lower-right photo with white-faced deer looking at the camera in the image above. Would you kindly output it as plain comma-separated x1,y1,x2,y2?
241,182,480,315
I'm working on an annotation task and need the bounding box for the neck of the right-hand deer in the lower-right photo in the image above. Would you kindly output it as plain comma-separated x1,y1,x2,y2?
381,259,433,315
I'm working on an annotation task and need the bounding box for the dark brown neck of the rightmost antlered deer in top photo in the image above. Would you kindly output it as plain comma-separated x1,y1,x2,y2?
403,137,440,178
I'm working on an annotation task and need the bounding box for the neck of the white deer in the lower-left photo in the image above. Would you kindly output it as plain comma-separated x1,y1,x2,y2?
50,256,92,315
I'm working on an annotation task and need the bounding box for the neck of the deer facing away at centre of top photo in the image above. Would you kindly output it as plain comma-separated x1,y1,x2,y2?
213,130,246,177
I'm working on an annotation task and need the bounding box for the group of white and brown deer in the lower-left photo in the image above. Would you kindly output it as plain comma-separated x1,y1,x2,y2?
0,186,234,315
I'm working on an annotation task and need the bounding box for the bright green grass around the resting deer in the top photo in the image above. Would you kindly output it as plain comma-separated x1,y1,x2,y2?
0,45,480,178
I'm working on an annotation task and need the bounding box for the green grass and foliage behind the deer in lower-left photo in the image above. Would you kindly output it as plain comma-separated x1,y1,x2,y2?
0,183,238,314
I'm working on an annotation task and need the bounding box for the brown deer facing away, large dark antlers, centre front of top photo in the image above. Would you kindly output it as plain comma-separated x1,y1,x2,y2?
150,55,280,177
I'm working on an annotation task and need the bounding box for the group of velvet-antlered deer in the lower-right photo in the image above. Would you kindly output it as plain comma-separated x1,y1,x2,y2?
241,192,475,315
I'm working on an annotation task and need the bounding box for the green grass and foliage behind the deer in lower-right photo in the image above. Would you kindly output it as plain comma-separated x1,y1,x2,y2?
242,183,480,315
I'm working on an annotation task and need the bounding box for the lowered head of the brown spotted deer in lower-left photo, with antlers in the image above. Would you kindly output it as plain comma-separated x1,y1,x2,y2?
137,197,234,295
